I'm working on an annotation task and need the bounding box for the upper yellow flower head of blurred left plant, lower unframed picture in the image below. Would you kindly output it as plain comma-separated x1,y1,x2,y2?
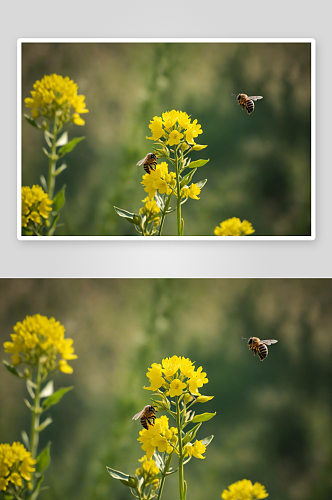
4,314,77,375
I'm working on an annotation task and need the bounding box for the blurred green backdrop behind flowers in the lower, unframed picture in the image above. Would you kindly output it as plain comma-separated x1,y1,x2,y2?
0,279,332,500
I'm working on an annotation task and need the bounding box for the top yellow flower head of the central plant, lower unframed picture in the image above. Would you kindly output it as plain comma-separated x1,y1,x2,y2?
144,356,208,398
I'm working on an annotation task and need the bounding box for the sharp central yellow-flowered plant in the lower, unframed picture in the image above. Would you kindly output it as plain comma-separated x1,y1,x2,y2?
107,356,215,500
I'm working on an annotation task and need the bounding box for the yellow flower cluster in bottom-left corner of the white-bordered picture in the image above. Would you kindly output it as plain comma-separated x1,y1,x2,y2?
21,185,53,227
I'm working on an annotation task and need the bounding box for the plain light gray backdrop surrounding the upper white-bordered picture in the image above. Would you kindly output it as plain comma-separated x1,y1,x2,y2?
0,0,332,277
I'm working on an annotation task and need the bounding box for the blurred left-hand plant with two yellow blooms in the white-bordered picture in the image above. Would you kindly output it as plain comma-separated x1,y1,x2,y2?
22,74,89,236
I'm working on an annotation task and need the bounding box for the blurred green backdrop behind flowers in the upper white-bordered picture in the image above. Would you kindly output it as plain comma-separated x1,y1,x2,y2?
22,43,311,236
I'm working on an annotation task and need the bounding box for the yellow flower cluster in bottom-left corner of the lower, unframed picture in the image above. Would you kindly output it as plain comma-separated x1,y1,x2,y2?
0,443,36,491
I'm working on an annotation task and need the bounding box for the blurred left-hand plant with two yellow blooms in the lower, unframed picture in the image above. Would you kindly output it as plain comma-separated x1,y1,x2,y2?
0,314,77,500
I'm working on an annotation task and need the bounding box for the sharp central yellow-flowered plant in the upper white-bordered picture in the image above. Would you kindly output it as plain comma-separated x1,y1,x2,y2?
114,109,209,236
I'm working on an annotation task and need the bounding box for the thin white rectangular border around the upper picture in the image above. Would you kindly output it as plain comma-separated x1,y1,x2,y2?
17,38,316,242
